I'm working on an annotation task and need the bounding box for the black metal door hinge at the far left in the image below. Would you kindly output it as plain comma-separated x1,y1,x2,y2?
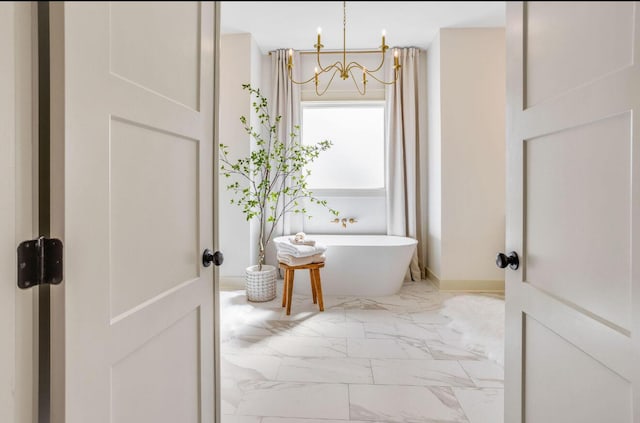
18,237,63,289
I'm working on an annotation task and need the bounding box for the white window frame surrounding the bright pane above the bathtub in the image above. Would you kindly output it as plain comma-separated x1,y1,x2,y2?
300,100,387,197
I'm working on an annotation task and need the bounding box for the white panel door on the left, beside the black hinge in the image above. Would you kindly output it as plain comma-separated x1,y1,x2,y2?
52,2,216,423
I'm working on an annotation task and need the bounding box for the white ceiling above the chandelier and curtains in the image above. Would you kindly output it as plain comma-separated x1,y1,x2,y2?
221,1,505,53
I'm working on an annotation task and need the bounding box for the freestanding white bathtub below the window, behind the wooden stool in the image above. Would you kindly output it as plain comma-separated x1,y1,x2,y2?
276,234,418,297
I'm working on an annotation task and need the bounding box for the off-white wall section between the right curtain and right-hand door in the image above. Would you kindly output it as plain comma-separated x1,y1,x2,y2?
429,28,505,286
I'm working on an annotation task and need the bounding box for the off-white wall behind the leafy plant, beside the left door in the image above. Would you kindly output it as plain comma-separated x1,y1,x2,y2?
218,34,262,278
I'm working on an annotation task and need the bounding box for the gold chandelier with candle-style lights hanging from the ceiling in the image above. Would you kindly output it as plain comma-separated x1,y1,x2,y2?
287,1,400,96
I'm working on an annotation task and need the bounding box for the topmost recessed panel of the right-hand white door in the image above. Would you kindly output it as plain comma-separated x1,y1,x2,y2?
523,2,635,109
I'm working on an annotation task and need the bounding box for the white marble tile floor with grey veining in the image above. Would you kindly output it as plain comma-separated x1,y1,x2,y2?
221,281,504,423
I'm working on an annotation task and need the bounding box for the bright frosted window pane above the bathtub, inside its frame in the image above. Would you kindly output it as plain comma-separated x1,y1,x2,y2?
302,105,384,189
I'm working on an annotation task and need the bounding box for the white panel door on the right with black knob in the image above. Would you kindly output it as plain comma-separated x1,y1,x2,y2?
505,2,640,423
